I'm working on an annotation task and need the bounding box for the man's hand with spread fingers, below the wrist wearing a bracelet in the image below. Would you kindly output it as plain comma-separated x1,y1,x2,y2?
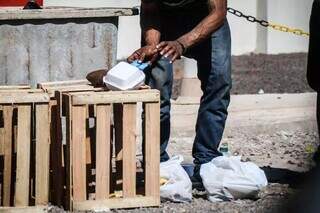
157,40,185,63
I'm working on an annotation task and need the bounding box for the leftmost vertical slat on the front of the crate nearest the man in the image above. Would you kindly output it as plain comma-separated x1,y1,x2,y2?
72,106,87,201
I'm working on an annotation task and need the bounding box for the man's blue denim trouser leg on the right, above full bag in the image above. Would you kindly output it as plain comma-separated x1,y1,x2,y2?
192,21,232,165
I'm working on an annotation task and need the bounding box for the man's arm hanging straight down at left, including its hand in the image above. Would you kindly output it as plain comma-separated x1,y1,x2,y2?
128,0,161,63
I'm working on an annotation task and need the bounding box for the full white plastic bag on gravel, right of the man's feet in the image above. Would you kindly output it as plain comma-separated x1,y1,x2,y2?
200,156,268,202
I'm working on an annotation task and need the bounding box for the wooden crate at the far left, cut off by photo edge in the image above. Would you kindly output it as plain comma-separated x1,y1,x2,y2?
0,87,50,211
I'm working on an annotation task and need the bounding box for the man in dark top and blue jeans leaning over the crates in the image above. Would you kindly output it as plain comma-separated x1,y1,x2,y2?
128,0,231,181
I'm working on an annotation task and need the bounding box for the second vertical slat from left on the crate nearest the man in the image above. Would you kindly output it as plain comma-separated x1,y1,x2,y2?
96,105,111,200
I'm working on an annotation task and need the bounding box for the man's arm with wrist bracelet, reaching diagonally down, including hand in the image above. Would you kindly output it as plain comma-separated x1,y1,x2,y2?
157,0,227,62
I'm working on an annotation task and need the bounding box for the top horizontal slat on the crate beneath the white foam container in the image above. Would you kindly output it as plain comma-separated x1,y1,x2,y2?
71,90,160,105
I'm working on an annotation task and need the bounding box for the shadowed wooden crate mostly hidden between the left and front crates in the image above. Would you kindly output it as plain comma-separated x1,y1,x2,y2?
38,80,104,208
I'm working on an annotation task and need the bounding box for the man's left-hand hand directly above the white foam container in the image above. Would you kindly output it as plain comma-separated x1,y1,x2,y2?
127,45,159,64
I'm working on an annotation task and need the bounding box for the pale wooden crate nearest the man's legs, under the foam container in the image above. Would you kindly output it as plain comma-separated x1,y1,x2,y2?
63,90,160,211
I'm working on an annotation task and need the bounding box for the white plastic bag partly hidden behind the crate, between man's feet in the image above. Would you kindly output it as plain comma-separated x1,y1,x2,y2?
160,155,192,202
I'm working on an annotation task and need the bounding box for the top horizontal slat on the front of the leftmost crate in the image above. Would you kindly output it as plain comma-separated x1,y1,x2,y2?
0,93,50,104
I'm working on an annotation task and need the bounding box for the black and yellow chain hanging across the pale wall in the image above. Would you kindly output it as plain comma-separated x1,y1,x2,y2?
228,7,309,37
